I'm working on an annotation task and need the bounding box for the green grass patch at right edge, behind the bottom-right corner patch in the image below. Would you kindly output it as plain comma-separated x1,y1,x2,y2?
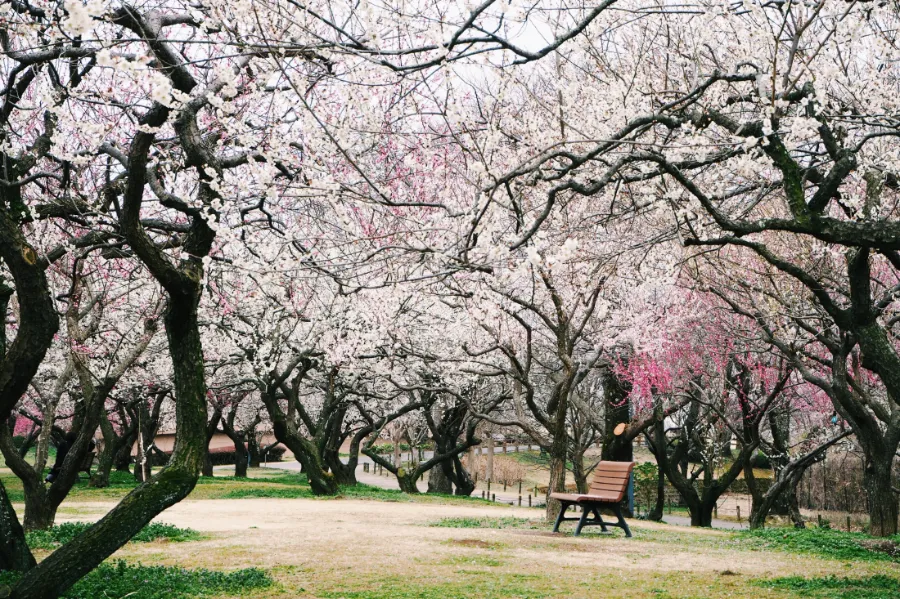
738,528,900,561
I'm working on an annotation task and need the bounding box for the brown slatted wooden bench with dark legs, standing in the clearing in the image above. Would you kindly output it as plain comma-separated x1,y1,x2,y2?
550,462,634,537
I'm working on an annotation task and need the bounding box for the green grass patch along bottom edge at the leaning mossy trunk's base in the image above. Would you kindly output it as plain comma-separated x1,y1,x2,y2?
0,561,272,599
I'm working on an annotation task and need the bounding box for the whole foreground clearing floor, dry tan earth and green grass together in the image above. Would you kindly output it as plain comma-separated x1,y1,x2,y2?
0,470,900,599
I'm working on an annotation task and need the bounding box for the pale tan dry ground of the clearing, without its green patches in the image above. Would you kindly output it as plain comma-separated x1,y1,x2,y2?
33,498,896,599
